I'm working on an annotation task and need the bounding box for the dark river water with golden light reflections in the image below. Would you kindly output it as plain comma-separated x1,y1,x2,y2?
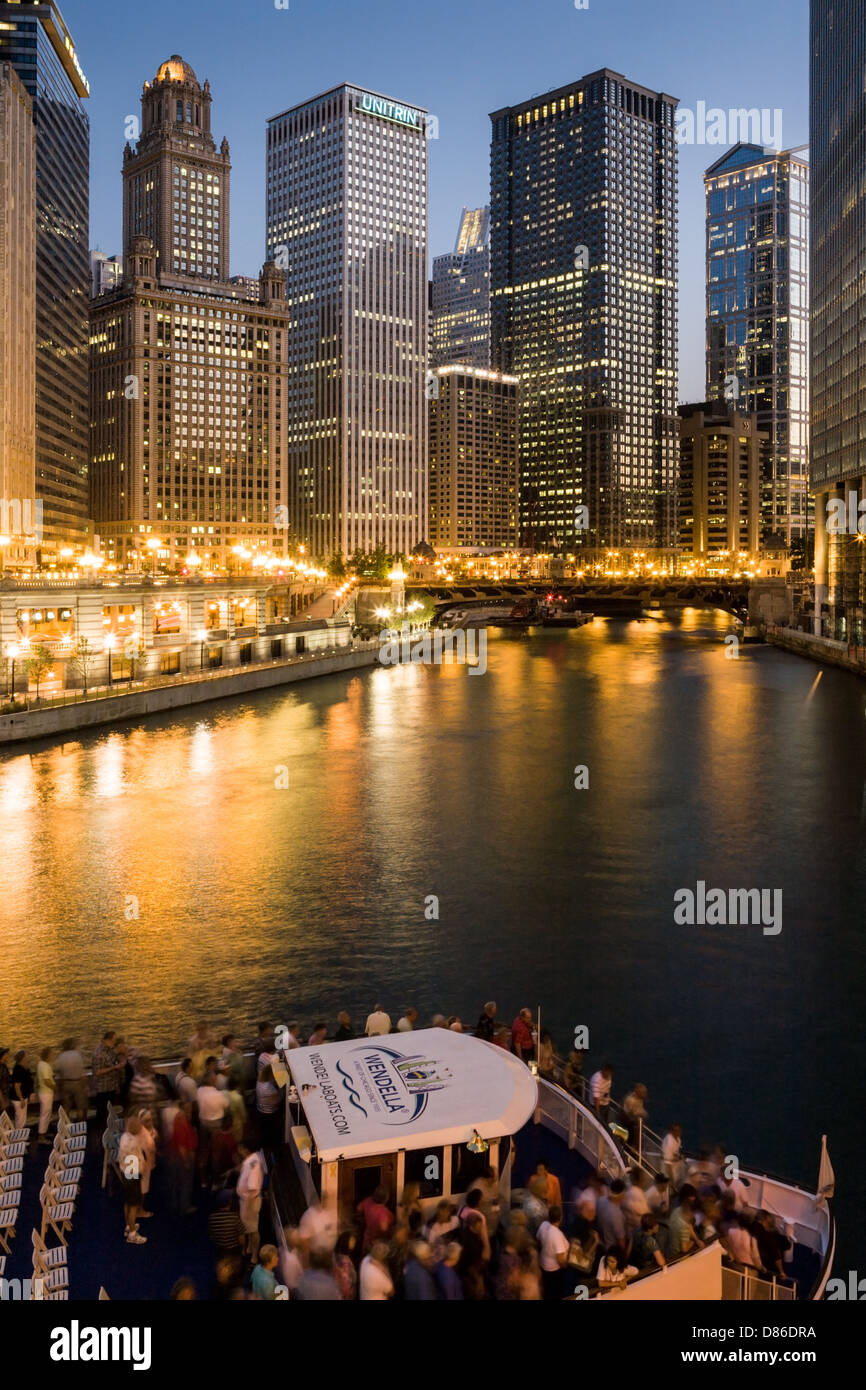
0,610,866,1268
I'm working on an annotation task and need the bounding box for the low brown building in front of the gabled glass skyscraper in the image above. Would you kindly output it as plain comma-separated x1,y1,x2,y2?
677,402,770,570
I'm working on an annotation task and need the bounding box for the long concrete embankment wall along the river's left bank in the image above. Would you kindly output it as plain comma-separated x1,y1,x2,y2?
0,645,378,746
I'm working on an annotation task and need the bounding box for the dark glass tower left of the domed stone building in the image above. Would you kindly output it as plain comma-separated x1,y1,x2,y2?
0,0,90,556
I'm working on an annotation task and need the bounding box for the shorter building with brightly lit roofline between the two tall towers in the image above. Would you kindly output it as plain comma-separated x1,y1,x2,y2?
430,364,520,550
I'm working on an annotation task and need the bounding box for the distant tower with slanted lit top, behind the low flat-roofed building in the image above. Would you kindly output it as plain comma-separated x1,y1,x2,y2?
430,207,491,367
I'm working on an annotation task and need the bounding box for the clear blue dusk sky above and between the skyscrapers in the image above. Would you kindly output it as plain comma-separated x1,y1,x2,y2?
60,0,809,400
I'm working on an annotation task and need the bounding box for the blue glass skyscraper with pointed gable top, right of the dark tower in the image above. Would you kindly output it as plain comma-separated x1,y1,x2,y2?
703,145,809,545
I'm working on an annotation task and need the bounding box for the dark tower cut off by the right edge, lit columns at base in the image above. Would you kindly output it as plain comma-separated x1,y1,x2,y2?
809,0,866,642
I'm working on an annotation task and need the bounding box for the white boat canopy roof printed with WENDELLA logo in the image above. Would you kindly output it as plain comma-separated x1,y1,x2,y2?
286,1029,538,1163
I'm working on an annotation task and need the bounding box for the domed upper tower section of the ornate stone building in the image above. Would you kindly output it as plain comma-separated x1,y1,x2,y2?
124,53,231,285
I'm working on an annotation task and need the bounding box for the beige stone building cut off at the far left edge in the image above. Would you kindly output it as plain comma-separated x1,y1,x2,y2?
0,63,38,570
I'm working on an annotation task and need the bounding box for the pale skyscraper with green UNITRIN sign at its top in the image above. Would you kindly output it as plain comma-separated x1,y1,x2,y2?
267,83,427,556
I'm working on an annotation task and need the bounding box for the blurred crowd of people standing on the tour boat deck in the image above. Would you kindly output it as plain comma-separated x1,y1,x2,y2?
0,1001,790,1301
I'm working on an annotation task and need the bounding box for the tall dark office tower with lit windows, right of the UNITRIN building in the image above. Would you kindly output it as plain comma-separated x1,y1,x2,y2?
491,68,677,553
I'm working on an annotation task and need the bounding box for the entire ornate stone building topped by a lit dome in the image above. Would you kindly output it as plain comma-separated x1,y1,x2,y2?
90,57,289,573
